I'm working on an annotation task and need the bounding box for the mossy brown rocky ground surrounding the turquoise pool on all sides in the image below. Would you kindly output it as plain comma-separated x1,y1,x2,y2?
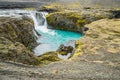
0,0,120,80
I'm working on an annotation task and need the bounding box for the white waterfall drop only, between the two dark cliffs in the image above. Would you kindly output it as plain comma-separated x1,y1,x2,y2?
32,12,55,35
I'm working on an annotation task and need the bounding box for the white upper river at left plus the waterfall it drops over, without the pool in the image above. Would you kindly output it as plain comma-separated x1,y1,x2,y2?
0,10,55,35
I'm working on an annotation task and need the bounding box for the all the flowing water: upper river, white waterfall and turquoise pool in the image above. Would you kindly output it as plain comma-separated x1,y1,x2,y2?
0,10,82,55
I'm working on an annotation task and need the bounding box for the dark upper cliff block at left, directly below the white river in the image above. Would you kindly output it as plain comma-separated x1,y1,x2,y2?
0,17,37,49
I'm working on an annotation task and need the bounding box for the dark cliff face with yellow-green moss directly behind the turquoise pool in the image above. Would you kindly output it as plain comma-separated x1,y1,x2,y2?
46,12,86,33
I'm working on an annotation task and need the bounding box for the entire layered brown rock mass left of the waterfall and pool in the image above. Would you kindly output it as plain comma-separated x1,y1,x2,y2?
0,17,38,64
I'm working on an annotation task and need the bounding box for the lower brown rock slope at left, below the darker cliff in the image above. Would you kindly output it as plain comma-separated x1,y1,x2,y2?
0,37,39,65
